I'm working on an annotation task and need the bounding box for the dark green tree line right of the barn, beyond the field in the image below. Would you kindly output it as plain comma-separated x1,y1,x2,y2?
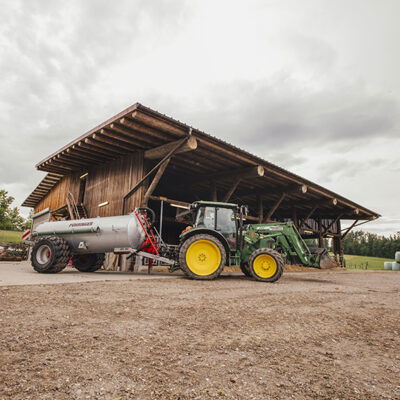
343,231,400,258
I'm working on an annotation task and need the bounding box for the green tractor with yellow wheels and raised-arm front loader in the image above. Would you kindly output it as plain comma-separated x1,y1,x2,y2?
178,201,336,282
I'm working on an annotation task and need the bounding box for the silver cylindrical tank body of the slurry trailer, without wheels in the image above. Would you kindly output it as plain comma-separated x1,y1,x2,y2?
32,214,145,254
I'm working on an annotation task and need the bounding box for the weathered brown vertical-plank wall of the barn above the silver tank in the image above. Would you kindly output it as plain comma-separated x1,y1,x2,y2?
35,152,145,218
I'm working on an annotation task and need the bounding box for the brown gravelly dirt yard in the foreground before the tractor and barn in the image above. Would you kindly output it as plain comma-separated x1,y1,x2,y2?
0,271,400,400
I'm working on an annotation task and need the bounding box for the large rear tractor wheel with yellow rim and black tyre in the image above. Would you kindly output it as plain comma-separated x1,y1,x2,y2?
179,234,226,280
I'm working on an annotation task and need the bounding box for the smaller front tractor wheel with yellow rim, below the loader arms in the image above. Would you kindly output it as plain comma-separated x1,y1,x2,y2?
249,248,284,282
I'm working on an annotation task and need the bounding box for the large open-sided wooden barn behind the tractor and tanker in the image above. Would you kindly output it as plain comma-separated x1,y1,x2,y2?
22,103,379,268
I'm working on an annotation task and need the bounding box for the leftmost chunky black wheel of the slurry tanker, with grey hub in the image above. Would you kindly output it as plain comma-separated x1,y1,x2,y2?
31,236,71,274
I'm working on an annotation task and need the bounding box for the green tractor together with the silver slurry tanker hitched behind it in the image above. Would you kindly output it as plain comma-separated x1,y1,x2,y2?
31,201,334,282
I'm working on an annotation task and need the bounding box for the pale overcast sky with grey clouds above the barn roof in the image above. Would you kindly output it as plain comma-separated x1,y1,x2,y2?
0,0,400,235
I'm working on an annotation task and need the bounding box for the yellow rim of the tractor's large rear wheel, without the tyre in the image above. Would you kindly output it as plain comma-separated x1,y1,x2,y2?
186,240,221,276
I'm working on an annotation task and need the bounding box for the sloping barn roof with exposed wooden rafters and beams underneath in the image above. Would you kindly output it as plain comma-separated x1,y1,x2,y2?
22,103,379,219
